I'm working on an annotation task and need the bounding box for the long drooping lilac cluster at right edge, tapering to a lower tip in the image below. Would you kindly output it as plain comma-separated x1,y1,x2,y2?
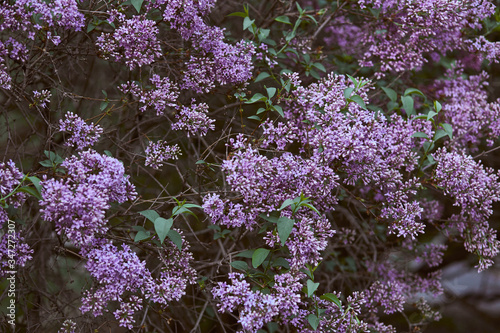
433,148,500,271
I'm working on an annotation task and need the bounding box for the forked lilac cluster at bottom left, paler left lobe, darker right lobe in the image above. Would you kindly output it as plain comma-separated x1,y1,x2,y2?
80,230,196,329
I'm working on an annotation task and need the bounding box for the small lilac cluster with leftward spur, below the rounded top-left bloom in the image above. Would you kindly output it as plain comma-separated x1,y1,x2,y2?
118,74,179,116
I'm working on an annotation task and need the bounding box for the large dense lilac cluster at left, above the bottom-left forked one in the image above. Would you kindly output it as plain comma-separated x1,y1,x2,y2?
40,150,136,244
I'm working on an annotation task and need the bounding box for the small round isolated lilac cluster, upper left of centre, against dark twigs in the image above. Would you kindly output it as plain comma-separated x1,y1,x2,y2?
172,100,215,137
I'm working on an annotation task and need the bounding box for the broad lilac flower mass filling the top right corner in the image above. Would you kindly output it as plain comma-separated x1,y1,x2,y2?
359,0,500,77
